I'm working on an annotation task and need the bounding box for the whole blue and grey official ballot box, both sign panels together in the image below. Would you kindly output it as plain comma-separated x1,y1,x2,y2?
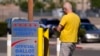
11,20,39,56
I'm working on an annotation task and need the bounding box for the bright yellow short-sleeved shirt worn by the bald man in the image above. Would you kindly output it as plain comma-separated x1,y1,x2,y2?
59,13,80,43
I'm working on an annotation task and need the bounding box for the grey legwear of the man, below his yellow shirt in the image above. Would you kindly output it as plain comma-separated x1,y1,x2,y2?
60,43,75,56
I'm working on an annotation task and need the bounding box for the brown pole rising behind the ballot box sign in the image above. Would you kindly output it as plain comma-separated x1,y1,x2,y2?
28,0,34,22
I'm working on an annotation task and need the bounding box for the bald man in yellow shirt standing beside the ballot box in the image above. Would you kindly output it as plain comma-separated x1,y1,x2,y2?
57,2,80,56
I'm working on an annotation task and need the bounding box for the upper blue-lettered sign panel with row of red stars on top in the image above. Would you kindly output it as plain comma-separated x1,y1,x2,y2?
12,22,39,37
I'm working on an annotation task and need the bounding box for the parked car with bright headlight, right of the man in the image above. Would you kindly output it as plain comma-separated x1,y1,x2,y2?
79,23,100,42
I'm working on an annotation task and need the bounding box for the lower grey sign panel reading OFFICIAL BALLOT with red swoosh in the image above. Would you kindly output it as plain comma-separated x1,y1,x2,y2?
11,38,37,56
